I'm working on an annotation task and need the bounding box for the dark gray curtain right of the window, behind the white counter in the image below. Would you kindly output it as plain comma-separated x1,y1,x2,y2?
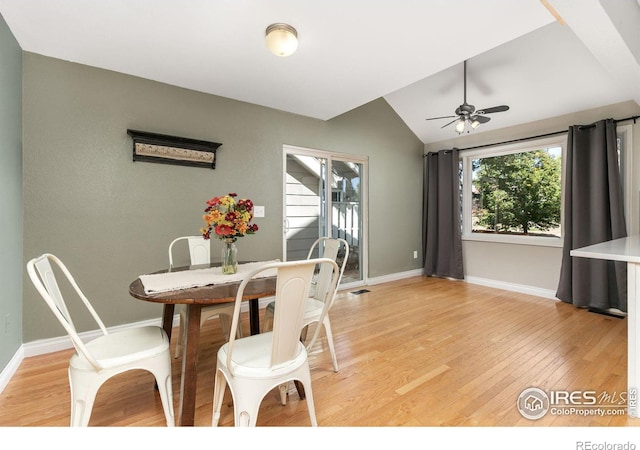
556,119,627,312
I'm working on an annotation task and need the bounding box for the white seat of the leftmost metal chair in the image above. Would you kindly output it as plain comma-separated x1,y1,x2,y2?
70,326,169,371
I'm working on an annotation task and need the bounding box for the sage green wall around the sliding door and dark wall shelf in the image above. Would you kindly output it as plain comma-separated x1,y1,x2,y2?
22,53,423,342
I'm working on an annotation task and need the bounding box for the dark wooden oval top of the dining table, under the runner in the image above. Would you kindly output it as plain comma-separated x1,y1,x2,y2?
129,263,276,305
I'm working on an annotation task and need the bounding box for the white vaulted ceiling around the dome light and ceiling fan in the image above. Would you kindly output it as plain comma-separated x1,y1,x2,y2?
0,0,640,143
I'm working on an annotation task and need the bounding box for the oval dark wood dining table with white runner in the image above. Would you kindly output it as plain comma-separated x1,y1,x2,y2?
129,261,277,426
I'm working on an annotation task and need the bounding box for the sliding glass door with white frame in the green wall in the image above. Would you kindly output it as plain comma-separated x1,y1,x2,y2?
283,146,367,286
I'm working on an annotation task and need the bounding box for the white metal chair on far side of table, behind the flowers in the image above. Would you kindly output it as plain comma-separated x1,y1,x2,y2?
169,236,242,358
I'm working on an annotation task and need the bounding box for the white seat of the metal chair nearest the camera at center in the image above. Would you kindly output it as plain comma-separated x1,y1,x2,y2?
218,331,307,380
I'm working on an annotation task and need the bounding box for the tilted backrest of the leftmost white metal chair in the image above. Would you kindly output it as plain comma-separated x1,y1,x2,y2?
27,253,108,370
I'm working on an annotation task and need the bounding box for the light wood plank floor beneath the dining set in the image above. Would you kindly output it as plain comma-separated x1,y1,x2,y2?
0,277,640,427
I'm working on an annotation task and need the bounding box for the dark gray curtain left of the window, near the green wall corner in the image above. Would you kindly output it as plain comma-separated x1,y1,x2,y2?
422,149,464,279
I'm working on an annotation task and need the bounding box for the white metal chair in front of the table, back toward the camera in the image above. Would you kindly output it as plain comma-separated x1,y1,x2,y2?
212,258,339,426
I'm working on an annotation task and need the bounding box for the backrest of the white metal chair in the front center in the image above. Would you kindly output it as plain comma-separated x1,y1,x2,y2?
227,258,339,374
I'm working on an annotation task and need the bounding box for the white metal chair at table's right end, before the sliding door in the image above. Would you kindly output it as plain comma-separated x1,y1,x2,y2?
264,237,349,370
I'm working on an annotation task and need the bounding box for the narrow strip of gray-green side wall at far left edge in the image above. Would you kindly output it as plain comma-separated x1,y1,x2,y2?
0,15,23,372
